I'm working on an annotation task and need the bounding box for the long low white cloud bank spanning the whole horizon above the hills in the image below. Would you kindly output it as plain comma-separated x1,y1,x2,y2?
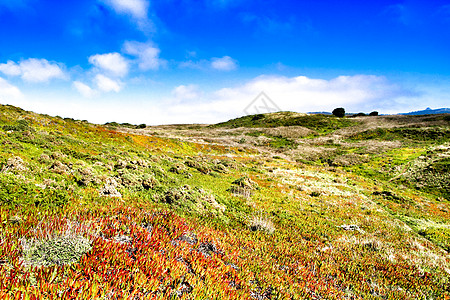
6,74,436,125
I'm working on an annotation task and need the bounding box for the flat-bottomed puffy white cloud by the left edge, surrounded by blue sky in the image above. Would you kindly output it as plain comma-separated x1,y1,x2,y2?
0,58,67,82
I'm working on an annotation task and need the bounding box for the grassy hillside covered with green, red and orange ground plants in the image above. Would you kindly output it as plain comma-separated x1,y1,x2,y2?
0,106,450,299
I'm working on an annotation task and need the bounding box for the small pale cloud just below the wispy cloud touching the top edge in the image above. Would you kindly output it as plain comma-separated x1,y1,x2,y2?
123,41,167,71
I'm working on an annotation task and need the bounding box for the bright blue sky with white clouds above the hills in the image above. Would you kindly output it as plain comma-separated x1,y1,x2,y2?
0,0,450,124
